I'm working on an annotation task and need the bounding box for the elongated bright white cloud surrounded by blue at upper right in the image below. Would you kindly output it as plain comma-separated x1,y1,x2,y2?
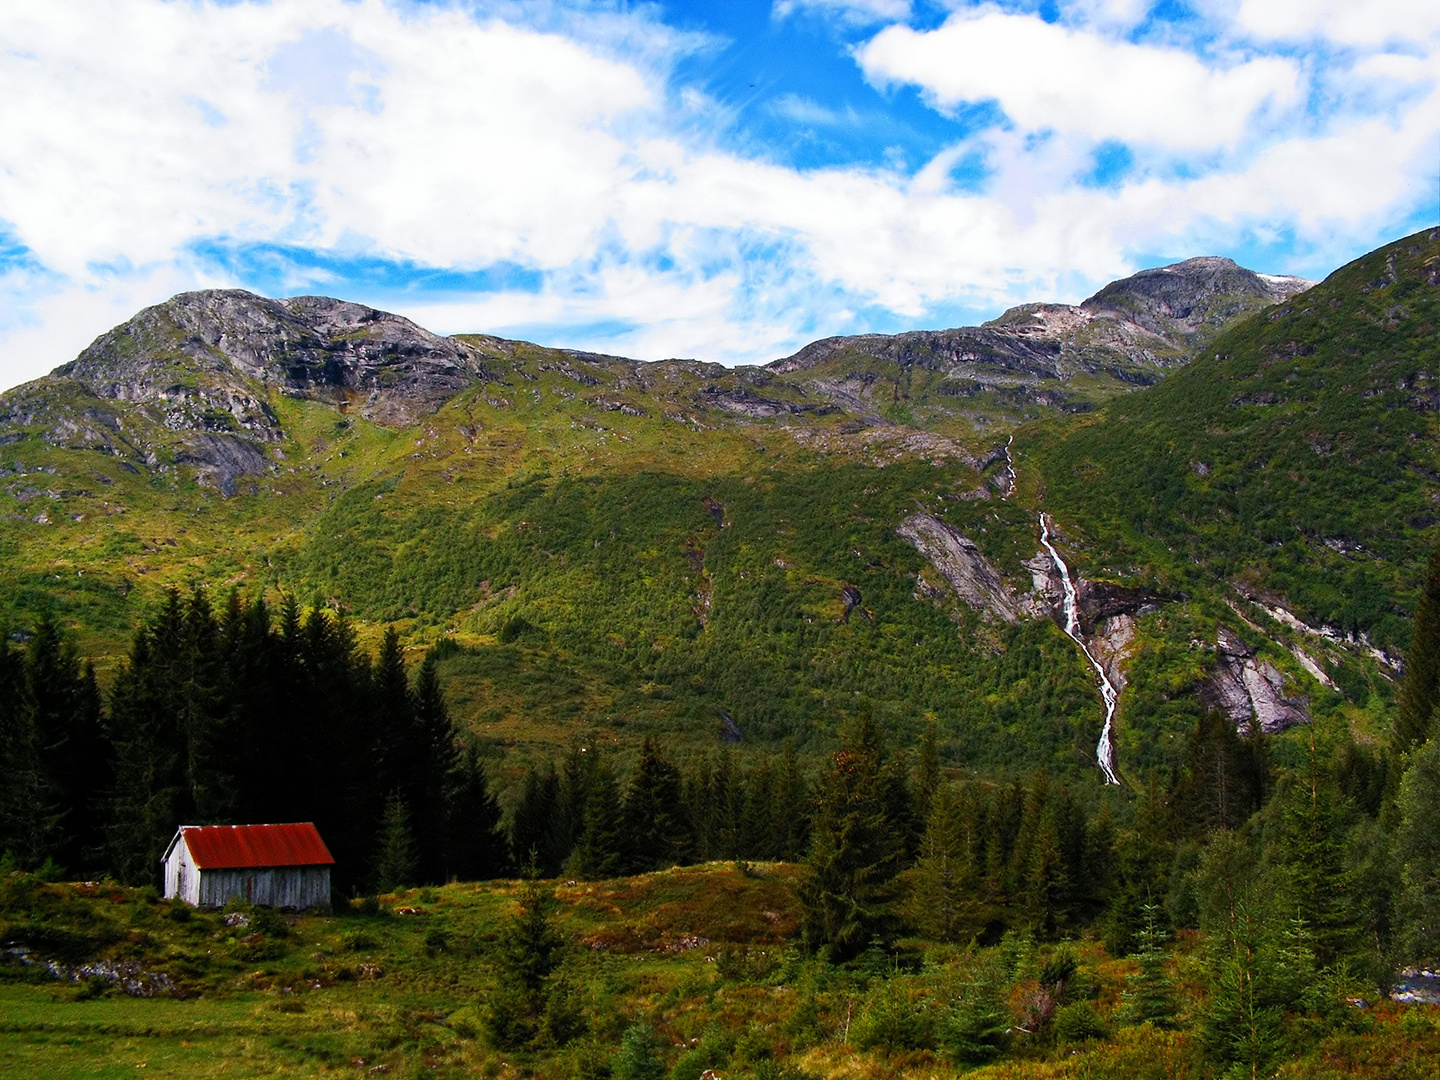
855,7,1300,150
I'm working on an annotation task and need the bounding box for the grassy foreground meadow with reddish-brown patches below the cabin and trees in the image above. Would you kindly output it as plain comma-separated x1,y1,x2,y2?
0,864,1440,1080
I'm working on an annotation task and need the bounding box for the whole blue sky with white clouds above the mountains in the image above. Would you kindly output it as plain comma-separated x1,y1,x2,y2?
0,0,1440,387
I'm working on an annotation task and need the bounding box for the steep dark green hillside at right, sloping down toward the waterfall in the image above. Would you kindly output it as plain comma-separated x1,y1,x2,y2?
1024,232,1440,654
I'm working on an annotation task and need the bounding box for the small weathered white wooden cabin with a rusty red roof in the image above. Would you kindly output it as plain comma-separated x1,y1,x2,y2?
161,821,336,910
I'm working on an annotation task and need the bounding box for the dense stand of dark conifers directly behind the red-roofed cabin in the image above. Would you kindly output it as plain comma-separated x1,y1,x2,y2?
0,590,508,893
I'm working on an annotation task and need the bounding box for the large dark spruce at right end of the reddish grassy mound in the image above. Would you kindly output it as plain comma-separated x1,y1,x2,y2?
799,717,904,959
